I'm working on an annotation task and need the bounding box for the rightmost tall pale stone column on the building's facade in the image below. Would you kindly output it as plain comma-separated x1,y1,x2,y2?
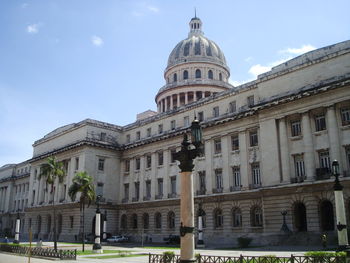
326,105,342,171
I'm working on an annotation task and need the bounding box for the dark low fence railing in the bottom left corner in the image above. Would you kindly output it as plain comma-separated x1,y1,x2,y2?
0,244,77,260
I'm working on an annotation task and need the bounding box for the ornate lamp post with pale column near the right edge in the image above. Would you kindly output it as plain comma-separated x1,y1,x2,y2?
332,160,349,250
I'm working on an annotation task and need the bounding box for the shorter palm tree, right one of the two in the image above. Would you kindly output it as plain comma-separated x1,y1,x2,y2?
68,172,96,251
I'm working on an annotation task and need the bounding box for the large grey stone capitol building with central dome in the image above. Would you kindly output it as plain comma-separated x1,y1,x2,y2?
0,17,350,247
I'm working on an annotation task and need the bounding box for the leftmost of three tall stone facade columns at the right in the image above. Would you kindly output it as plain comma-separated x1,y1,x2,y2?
279,118,291,183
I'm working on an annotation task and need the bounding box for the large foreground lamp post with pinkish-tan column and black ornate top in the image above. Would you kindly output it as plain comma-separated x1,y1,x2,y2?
175,119,202,263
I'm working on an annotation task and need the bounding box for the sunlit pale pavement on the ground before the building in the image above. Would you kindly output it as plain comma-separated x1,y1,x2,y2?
0,242,336,263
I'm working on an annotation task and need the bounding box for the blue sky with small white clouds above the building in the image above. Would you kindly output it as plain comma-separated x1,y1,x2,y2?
0,0,350,166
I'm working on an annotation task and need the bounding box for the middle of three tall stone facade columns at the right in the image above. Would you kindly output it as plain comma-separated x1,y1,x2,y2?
301,112,316,181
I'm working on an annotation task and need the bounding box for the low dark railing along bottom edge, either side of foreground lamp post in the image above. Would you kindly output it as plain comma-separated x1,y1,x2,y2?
148,254,346,263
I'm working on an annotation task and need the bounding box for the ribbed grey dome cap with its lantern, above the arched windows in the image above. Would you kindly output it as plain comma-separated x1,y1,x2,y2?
167,17,229,71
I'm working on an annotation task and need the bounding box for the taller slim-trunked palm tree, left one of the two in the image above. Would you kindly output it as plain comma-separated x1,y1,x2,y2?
39,156,66,251
